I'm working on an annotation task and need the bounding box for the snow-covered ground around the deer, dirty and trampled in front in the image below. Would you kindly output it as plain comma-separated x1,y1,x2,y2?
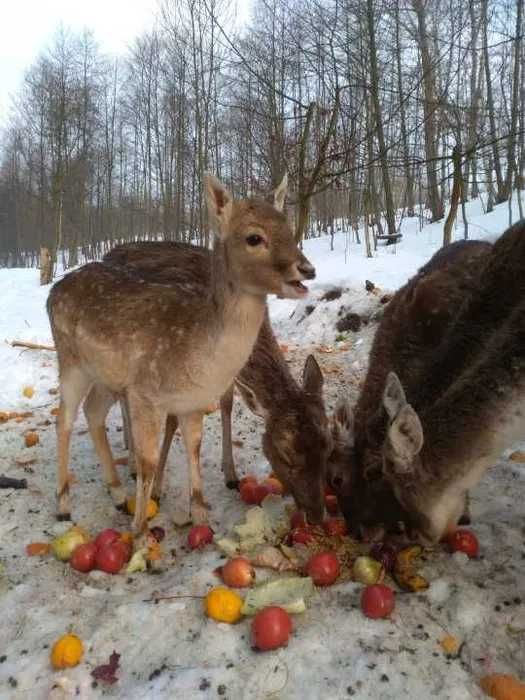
0,194,525,700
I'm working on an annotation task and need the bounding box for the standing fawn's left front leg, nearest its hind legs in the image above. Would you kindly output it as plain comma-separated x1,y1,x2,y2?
127,393,166,547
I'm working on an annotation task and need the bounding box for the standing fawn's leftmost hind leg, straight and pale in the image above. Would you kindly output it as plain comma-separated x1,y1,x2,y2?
57,367,91,520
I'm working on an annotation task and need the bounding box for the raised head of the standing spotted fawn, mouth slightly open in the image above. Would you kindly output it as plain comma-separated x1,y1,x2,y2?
204,175,315,299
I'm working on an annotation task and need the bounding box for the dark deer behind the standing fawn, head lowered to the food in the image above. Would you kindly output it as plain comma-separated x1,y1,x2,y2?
103,241,331,522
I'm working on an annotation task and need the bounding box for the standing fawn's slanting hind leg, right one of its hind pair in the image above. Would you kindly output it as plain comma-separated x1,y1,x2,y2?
84,384,126,510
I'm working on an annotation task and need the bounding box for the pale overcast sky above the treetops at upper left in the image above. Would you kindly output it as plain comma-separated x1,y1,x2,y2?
0,0,157,125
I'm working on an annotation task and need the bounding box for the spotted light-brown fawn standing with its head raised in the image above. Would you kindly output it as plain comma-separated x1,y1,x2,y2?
47,176,315,534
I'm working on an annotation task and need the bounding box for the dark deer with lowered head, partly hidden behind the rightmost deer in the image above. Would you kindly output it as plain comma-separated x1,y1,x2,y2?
329,241,502,531
